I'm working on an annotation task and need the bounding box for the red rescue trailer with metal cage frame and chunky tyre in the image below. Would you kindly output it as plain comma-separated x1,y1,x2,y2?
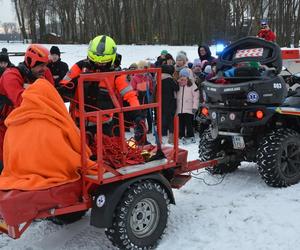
0,68,222,249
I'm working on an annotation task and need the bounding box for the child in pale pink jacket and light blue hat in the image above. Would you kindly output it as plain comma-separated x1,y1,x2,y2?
176,68,199,144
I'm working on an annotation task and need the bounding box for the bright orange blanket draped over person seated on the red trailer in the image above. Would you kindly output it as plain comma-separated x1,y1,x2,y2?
0,79,95,190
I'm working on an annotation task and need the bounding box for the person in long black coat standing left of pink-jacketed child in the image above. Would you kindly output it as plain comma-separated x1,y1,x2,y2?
161,64,179,143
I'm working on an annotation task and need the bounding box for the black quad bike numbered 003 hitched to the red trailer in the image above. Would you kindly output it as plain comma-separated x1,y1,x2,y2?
199,37,300,187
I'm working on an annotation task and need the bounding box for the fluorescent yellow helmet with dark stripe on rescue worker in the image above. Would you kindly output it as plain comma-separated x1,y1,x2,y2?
88,35,117,64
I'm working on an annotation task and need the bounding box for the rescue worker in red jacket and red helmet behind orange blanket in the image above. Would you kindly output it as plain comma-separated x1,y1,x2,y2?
0,44,54,172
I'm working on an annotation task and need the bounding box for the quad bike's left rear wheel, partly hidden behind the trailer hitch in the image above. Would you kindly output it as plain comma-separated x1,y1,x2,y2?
198,130,240,174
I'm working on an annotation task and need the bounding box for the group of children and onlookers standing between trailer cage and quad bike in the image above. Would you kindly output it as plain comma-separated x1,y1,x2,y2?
127,45,216,144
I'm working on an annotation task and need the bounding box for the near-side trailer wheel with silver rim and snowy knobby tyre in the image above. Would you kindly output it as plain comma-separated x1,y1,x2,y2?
106,180,170,249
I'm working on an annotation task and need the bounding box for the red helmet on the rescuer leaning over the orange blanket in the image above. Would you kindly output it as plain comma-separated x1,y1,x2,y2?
25,44,50,68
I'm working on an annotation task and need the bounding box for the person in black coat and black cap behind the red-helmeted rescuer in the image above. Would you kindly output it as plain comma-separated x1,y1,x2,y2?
48,46,69,87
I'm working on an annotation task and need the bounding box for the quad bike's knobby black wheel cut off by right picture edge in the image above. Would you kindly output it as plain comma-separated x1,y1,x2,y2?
256,129,300,187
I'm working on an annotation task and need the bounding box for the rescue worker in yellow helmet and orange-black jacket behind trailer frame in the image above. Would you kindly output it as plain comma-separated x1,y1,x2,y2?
60,35,144,141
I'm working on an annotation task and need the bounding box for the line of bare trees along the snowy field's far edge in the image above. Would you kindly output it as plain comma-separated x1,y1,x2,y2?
11,0,300,46
